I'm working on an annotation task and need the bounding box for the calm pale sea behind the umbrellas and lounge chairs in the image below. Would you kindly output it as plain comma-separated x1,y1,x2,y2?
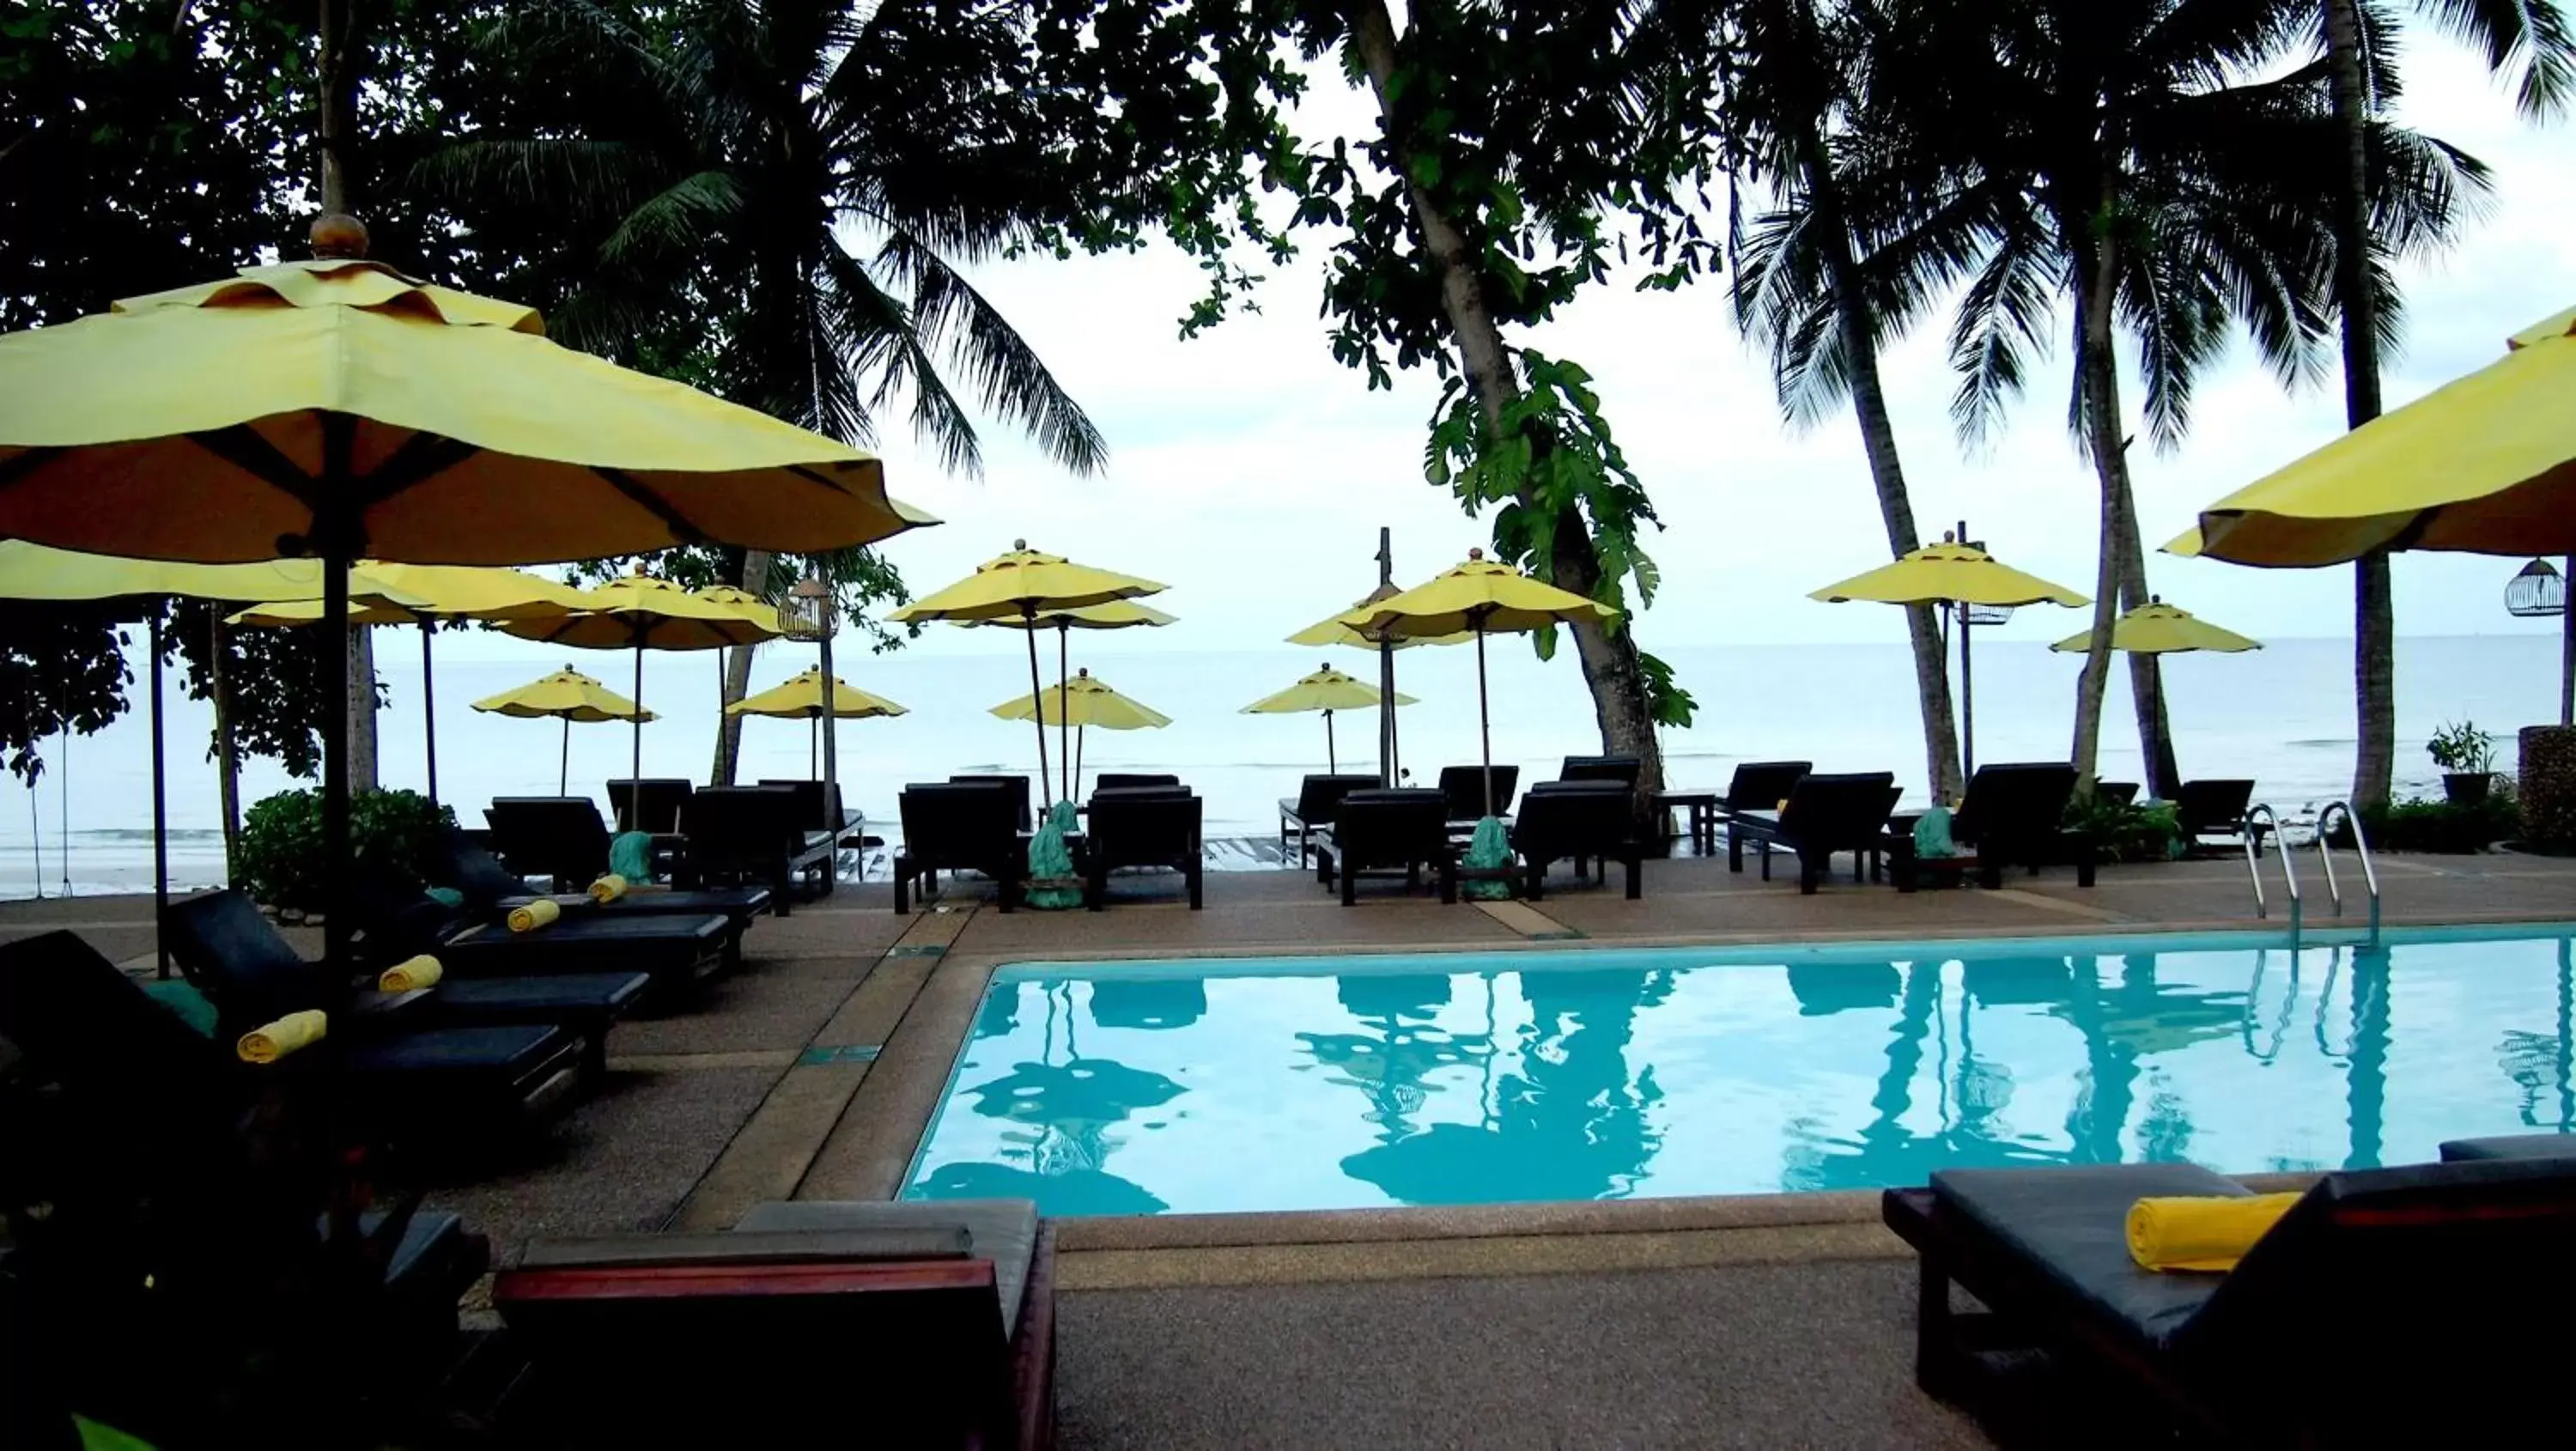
0,634,2558,897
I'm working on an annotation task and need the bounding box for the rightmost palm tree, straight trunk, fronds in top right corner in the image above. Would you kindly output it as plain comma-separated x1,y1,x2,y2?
2316,0,2576,807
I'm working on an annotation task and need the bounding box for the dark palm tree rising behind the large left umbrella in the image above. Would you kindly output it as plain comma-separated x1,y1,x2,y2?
422,0,1108,779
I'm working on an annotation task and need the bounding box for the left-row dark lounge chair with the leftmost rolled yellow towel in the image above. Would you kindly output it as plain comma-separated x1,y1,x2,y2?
162,892,592,1137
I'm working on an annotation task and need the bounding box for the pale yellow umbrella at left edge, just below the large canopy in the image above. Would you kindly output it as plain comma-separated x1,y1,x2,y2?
0,538,422,977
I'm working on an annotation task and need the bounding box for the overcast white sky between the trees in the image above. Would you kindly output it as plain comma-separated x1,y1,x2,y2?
453,33,2576,652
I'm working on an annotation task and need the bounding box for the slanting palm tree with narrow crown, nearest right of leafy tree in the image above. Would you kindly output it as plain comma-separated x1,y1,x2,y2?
1728,0,1965,802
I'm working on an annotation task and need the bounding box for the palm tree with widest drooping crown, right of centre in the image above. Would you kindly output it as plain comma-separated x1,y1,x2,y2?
1855,0,2483,792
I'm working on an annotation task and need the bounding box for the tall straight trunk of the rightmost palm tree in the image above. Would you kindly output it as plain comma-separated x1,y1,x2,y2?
2326,0,2398,807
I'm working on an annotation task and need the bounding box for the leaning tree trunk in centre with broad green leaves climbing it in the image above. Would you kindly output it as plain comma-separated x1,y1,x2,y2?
1352,0,1664,820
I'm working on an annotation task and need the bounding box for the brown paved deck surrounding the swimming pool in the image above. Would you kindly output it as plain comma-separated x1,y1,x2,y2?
0,851,2576,1448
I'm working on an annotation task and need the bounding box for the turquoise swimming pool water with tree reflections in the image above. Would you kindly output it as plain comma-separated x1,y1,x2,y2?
904,928,2576,1214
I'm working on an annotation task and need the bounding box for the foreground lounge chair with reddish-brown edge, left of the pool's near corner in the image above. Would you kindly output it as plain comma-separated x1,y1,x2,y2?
492,1201,1056,1451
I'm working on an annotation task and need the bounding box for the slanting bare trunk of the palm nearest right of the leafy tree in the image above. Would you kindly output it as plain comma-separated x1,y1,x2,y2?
1798,124,1968,802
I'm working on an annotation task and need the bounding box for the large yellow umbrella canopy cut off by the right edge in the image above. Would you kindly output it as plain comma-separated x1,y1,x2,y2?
2166,309,2576,567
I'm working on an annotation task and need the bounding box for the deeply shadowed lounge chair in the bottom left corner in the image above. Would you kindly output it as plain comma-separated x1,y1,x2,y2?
0,933,489,1448
